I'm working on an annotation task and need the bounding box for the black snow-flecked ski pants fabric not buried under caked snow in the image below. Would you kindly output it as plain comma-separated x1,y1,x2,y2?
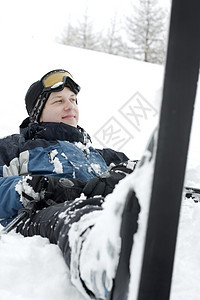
16,197,104,268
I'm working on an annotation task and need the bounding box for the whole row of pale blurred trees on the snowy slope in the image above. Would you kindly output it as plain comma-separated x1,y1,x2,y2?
59,0,169,64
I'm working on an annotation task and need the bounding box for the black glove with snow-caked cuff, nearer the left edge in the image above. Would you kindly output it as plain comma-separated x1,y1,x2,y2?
16,175,86,209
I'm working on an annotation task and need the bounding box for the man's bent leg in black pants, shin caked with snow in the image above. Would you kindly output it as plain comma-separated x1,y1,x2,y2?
17,191,140,299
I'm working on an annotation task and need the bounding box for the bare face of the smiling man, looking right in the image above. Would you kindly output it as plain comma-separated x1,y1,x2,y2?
40,87,79,127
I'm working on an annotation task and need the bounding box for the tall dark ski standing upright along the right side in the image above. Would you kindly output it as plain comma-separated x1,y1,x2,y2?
137,0,200,300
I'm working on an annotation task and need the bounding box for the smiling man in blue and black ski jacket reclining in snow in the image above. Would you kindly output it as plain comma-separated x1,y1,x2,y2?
0,69,139,299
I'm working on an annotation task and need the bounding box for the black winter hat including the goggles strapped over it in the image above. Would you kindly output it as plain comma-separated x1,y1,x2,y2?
25,69,80,122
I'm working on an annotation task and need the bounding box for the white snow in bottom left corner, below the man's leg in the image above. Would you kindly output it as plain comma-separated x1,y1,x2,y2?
0,232,84,300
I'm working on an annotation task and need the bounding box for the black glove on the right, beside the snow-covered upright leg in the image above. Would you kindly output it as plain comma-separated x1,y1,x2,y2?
83,164,133,197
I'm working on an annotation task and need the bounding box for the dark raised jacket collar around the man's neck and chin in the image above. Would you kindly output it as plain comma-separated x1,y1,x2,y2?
20,118,91,144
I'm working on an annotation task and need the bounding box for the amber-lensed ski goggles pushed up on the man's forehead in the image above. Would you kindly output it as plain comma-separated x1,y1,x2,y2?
41,69,81,95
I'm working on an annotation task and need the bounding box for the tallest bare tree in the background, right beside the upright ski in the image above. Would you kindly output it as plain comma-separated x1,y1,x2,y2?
126,0,167,63
